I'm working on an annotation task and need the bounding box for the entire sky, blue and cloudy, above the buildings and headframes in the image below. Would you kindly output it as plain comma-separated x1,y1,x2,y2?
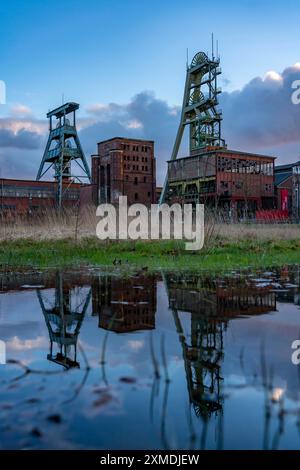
0,0,300,182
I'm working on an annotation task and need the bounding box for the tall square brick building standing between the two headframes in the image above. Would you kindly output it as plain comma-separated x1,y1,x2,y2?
92,137,156,205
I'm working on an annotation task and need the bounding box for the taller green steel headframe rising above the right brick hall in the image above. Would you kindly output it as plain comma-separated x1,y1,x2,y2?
160,52,226,203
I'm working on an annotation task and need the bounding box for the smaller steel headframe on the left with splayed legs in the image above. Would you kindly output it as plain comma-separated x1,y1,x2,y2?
36,103,91,208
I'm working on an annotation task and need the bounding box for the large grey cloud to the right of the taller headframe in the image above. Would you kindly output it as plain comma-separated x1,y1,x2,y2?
220,64,300,152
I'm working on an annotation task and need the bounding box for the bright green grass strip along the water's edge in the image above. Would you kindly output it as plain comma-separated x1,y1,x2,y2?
0,236,300,271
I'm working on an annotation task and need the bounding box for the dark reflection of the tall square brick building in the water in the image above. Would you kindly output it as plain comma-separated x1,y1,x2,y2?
92,275,156,333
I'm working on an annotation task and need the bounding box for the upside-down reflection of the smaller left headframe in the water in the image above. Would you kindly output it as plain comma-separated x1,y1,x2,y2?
37,272,91,369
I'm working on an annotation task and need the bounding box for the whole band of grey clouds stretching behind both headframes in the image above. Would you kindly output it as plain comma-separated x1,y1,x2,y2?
0,63,300,184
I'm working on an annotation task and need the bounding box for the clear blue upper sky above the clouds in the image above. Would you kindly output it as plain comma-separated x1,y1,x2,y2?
0,0,300,117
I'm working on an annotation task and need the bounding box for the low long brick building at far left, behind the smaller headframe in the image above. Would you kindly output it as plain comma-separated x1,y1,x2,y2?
0,178,82,219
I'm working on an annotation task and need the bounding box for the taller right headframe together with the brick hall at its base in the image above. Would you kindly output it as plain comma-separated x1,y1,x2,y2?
160,52,276,220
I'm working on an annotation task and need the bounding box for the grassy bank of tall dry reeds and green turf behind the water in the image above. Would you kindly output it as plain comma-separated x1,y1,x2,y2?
0,206,300,272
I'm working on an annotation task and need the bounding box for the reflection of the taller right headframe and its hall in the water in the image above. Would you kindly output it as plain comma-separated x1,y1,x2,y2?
165,275,276,420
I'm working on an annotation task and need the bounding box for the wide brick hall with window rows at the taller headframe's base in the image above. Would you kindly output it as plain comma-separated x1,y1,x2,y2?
166,149,275,218
